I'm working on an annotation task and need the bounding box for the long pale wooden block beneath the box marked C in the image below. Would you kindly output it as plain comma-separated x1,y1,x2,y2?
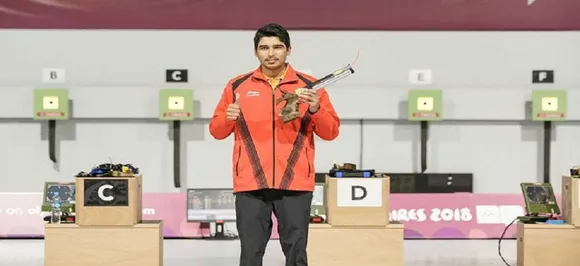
44,221,163,266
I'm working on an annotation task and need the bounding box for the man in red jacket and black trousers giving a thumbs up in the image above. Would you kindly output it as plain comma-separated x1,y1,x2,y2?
209,24,340,266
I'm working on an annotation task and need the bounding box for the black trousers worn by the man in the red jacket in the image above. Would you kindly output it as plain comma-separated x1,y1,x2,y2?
236,190,312,266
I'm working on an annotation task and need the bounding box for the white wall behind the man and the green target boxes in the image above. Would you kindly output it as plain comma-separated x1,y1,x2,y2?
0,30,580,193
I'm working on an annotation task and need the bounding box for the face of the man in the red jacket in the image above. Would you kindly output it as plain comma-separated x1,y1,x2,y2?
256,37,290,70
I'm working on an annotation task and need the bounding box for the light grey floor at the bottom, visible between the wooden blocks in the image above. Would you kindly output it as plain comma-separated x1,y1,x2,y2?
0,240,516,266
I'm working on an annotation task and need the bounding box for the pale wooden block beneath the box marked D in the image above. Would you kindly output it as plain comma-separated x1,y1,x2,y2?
307,223,404,266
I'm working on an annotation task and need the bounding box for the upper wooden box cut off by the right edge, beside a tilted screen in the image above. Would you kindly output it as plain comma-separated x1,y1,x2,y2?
562,176,580,226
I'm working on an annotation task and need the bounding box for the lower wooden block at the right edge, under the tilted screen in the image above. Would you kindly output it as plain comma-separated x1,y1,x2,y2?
517,223,580,266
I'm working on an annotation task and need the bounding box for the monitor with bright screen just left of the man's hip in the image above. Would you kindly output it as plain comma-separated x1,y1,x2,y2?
186,188,236,222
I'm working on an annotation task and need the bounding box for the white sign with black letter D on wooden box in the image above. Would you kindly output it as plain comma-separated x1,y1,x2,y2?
336,178,383,207
